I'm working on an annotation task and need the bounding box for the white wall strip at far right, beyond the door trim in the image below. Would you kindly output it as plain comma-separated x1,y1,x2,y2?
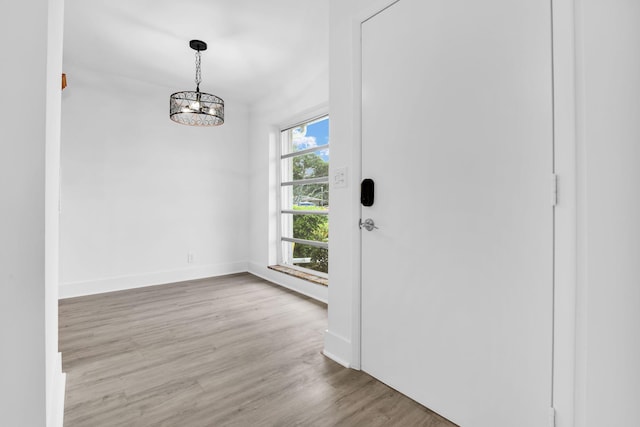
576,0,640,427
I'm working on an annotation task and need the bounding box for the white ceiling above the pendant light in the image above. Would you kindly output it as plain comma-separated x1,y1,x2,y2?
63,0,329,104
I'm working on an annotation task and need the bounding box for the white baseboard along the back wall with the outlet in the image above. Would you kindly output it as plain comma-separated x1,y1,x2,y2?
59,262,247,299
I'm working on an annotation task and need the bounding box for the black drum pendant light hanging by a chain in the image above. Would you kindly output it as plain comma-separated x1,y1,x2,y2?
169,40,224,126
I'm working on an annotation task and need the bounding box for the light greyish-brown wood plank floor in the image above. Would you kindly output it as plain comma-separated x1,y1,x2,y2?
60,274,454,427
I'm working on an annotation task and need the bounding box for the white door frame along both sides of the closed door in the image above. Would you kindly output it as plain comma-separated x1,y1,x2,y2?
350,0,577,427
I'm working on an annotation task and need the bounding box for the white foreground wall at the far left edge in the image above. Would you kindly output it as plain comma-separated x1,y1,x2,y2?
0,0,63,427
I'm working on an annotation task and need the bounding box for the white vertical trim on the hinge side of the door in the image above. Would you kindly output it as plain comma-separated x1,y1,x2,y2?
551,0,579,427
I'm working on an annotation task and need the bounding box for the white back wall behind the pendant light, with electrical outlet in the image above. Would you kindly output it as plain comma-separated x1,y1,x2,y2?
60,69,250,297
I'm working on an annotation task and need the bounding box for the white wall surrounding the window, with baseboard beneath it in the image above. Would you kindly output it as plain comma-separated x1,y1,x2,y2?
249,59,333,302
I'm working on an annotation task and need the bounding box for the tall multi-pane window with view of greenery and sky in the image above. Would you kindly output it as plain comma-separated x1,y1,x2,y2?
279,116,329,277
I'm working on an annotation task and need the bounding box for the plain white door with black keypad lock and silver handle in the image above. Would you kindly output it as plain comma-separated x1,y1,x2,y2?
361,0,553,427
